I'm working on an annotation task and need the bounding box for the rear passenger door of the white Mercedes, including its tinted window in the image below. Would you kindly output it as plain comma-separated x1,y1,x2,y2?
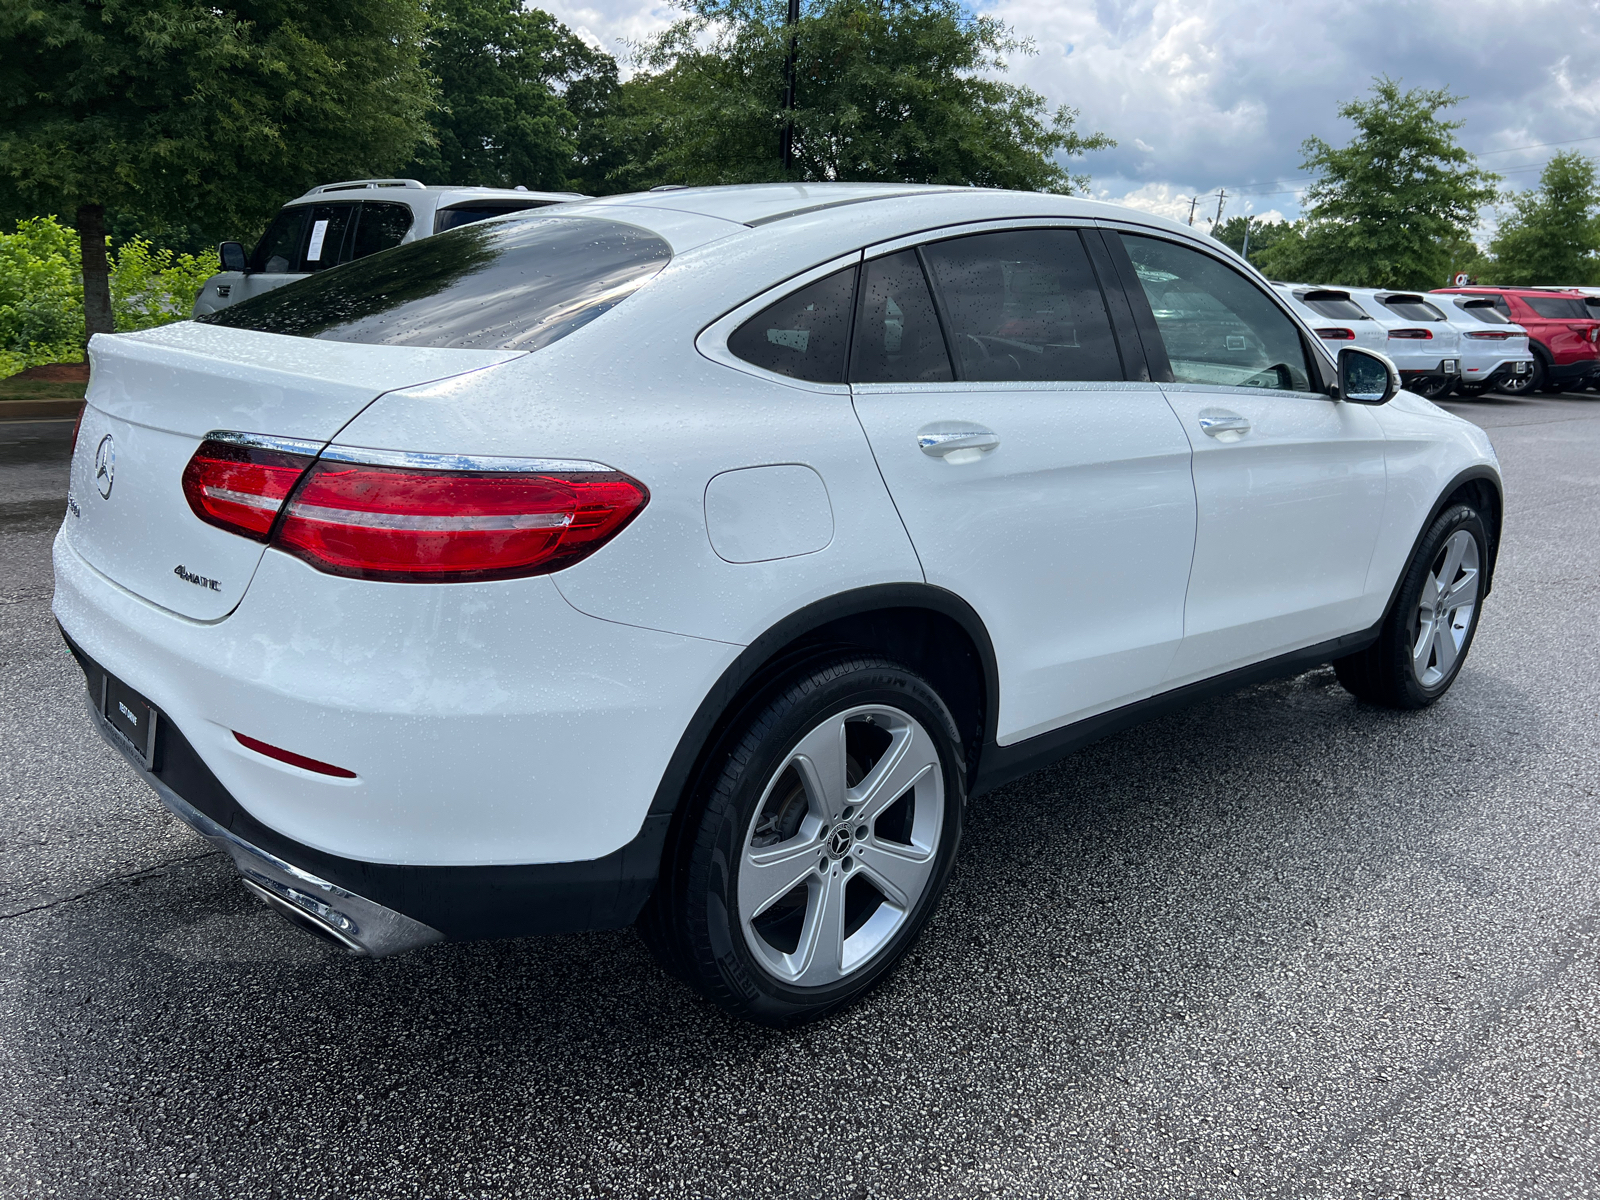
850,227,1195,744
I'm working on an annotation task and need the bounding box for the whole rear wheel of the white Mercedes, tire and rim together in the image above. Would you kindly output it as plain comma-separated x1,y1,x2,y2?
640,654,966,1027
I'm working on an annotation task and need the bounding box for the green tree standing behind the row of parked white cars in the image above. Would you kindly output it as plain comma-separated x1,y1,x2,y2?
1301,77,1498,288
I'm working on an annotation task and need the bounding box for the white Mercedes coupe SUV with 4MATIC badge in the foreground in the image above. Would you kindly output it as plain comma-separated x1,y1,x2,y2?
54,184,1501,1026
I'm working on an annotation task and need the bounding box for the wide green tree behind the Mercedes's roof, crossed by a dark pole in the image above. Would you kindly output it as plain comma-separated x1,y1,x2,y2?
616,0,1114,192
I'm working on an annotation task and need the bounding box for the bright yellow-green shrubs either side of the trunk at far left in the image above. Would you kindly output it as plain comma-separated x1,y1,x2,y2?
0,216,216,378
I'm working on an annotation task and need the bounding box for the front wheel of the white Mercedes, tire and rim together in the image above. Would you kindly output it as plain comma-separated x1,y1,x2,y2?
1333,504,1490,709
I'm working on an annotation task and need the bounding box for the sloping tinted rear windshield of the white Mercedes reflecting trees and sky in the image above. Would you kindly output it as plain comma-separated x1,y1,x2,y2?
195,216,672,350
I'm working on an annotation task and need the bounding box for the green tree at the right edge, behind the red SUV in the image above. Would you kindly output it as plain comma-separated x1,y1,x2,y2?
1490,150,1600,286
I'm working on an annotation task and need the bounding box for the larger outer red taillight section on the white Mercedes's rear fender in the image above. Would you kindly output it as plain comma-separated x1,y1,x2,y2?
272,451,650,582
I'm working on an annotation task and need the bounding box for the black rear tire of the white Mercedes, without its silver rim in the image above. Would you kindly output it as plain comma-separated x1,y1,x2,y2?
685,659,966,1026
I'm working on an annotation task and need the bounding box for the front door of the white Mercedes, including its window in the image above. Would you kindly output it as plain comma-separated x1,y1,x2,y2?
1115,232,1386,685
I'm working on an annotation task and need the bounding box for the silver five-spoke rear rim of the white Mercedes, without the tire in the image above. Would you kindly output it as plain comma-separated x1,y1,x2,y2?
736,704,944,987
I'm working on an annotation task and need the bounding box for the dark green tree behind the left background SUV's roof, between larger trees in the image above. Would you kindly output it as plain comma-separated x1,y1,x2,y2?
405,0,618,190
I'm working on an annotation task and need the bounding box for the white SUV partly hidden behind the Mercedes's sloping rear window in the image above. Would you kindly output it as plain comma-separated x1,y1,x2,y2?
194,179,584,317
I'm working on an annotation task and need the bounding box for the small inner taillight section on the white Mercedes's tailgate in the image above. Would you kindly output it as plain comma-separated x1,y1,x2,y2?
184,434,322,542
